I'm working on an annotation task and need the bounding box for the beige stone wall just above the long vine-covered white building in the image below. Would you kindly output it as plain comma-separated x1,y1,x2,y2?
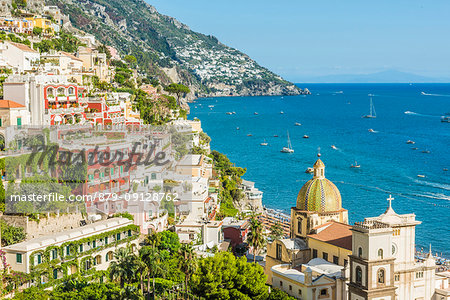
0,213,85,240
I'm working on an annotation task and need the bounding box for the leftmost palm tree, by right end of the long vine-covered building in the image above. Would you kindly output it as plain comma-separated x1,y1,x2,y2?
109,247,136,288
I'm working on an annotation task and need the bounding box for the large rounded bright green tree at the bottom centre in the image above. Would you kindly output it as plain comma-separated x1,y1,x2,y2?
191,252,268,300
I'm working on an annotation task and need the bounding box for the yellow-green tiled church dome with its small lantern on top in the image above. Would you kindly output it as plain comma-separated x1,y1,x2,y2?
297,159,342,213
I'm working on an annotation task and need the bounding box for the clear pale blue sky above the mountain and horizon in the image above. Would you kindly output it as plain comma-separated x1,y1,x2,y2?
146,0,450,81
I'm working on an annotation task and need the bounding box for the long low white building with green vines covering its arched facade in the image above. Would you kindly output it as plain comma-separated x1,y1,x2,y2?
3,218,139,283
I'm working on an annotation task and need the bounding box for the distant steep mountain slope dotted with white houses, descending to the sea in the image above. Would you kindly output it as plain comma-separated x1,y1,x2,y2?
48,0,303,97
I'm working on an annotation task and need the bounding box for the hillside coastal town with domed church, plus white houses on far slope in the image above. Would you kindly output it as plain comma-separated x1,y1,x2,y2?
0,0,450,300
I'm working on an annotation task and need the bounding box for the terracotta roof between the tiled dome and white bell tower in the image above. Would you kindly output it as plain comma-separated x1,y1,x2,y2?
308,221,352,250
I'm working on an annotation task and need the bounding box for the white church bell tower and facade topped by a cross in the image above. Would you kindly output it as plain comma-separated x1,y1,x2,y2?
349,197,440,300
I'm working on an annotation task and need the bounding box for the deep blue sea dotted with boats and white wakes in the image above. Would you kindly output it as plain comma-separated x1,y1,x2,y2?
189,84,450,257
